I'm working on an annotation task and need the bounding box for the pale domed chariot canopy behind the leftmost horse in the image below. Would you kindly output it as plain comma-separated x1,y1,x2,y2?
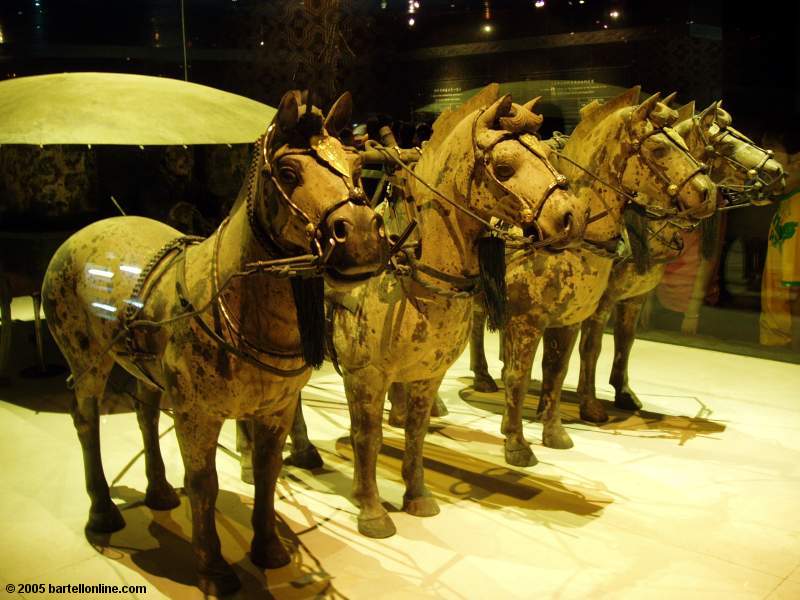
0,73,275,146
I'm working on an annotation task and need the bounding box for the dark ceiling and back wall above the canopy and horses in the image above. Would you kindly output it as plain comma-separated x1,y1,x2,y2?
0,0,800,137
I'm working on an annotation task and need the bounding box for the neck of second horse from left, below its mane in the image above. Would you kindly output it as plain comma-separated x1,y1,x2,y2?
414,137,487,277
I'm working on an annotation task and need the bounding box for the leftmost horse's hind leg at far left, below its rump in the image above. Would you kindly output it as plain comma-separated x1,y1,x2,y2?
71,356,125,533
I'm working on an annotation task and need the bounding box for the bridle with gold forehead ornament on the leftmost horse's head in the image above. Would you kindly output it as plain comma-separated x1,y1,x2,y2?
246,125,368,277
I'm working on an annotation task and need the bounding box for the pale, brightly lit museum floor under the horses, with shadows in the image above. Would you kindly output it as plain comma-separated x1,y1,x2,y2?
0,310,800,599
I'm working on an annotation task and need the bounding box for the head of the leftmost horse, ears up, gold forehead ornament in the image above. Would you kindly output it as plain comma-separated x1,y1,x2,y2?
250,90,388,285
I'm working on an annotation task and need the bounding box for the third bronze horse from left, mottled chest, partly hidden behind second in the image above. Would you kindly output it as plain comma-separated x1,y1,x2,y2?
471,87,714,466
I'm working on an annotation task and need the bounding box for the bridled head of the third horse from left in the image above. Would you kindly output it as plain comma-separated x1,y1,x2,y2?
620,93,715,222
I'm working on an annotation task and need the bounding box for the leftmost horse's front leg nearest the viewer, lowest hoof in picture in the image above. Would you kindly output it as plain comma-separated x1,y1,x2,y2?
175,410,241,596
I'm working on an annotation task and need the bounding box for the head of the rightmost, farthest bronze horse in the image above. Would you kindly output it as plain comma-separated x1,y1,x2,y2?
675,100,785,204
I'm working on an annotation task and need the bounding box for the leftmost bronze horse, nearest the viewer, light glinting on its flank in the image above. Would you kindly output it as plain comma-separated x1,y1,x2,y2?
42,91,388,595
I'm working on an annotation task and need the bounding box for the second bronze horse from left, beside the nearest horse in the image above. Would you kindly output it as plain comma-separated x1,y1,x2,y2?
280,84,587,538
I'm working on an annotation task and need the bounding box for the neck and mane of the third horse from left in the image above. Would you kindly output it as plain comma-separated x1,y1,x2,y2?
559,111,630,242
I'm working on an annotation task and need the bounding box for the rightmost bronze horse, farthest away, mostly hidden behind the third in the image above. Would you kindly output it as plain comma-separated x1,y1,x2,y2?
578,102,784,423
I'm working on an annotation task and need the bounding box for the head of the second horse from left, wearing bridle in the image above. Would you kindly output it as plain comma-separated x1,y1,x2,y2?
467,94,588,249
